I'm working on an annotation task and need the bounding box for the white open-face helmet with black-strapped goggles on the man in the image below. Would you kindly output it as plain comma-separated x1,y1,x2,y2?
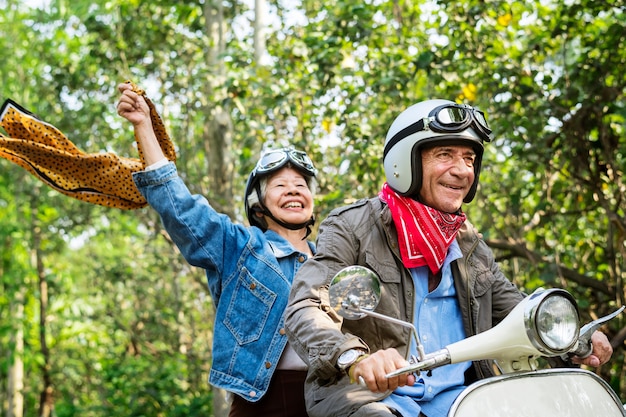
383,100,492,203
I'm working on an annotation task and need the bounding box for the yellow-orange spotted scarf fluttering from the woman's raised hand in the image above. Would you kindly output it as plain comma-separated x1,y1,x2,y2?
0,81,176,210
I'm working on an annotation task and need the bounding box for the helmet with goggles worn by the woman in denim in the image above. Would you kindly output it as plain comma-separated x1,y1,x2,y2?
244,147,317,231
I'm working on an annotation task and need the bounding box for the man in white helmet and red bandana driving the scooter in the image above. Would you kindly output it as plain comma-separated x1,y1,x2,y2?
286,100,612,417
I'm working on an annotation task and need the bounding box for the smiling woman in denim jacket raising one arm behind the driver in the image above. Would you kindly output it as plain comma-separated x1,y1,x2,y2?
117,83,317,417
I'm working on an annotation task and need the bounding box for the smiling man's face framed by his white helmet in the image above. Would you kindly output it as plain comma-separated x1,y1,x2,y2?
420,145,476,213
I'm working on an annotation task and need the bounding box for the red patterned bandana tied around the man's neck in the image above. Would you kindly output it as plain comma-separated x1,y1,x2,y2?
378,183,466,273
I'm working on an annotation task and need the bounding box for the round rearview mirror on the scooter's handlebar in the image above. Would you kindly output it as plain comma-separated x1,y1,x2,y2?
328,265,380,320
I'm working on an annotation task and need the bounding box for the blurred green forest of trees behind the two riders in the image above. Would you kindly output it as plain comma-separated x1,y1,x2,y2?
0,0,626,417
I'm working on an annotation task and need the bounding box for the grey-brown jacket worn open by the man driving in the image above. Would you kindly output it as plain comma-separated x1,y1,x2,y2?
285,198,524,417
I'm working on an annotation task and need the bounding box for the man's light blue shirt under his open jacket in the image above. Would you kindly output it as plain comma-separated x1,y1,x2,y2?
383,241,471,417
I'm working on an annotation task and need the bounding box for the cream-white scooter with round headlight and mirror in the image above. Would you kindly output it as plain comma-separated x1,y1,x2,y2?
329,266,626,417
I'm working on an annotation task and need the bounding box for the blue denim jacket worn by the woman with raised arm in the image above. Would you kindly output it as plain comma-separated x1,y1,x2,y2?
133,163,315,401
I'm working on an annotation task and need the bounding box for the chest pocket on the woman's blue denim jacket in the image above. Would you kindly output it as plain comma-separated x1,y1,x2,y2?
224,268,276,345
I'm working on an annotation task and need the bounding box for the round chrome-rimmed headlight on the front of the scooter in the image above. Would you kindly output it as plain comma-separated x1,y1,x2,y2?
525,289,580,356
